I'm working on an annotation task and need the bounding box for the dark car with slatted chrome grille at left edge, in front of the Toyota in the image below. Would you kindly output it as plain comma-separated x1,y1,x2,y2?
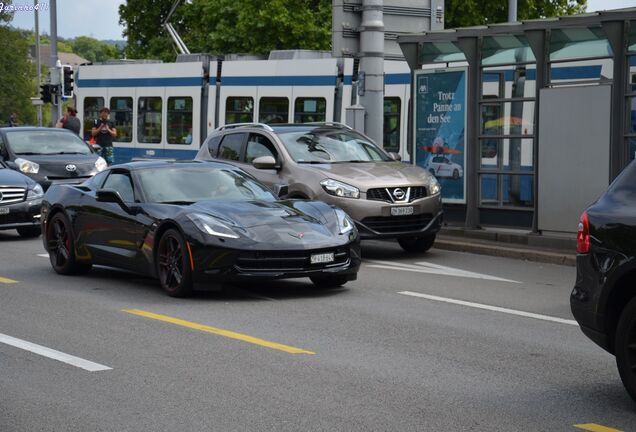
0,161,44,237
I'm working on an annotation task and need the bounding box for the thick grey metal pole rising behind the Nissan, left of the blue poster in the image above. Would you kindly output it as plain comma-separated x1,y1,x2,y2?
360,0,384,146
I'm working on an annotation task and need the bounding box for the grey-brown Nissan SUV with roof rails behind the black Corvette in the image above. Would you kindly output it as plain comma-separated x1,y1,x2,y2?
196,123,442,252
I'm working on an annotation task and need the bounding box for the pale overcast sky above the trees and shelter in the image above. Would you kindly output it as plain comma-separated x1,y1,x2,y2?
7,0,636,39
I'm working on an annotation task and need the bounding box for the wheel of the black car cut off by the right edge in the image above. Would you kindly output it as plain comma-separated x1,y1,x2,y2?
615,297,636,401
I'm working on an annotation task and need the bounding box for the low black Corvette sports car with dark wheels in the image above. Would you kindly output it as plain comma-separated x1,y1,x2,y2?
42,161,360,296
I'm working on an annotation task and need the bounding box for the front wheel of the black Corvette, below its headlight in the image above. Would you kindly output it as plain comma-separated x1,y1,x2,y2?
157,229,192,297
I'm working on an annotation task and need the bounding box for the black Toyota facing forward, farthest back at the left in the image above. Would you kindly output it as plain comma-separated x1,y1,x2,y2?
0,127,106,190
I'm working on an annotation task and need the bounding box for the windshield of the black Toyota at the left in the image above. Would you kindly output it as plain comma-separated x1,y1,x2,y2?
7,130,91,155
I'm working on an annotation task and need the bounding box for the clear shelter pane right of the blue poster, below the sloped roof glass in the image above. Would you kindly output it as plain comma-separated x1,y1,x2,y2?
481,65,537,99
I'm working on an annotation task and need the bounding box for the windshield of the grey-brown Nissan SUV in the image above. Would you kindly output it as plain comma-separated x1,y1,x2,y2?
279,128,393,163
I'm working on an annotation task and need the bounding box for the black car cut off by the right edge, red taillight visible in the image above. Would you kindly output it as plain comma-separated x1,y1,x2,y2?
570,162,636,401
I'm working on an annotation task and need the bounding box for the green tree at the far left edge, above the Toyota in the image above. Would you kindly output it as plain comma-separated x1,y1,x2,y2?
0,25,36,124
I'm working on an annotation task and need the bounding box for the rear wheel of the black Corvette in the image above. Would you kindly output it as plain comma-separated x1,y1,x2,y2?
46,213,91,275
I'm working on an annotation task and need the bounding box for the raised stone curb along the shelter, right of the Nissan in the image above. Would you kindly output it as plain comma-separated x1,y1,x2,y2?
433,238,576,266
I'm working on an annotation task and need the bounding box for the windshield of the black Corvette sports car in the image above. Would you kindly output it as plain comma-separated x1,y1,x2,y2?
137,166,276,204
